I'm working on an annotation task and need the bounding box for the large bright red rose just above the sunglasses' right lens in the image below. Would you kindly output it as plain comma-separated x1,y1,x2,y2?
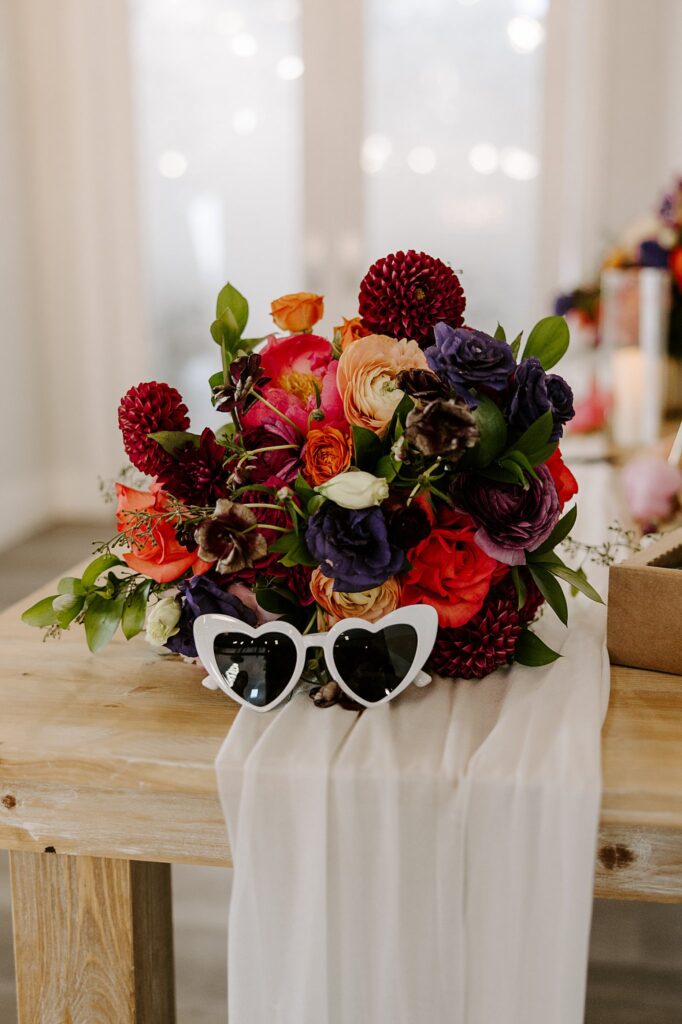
400,512,498,629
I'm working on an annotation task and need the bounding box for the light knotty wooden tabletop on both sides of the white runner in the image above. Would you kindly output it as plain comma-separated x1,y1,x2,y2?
0,573,682,900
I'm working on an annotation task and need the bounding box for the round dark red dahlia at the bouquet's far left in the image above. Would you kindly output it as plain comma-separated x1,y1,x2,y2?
119,381,189,476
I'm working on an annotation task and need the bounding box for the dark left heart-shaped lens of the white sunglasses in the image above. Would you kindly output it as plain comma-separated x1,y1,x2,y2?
214,633,296,708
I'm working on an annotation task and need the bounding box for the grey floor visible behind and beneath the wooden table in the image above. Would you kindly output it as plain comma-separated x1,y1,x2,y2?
0,523,682,1024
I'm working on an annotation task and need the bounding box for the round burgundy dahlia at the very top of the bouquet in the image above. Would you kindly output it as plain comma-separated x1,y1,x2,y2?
359,249,466,346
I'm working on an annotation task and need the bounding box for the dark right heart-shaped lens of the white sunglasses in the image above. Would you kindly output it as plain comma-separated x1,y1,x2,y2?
327,625,418,703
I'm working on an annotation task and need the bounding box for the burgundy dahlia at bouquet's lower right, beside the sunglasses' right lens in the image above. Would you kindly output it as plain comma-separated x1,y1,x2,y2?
430,588,524,679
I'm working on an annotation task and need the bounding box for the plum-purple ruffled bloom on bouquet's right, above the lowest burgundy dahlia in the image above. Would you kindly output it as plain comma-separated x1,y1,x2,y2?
453,466,561,565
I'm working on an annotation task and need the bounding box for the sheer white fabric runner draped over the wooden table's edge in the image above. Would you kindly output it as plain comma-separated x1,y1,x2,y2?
216,470,613,1024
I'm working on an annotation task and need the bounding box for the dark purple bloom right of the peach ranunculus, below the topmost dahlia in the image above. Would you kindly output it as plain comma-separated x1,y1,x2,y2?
424,324,516,407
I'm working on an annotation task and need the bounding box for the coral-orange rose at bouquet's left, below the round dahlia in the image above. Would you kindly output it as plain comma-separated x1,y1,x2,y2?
116,483,212,583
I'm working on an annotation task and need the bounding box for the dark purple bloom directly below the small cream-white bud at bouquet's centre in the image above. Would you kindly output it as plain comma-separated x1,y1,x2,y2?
305,502,404,594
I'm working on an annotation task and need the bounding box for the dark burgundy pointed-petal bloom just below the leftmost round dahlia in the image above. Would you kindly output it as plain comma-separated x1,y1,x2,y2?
157,427,229,505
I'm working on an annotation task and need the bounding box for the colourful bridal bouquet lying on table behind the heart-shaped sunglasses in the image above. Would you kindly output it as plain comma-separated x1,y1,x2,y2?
24,251,600,692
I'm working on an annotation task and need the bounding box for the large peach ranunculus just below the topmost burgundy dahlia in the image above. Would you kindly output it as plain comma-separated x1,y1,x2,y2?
336,334,428,434
